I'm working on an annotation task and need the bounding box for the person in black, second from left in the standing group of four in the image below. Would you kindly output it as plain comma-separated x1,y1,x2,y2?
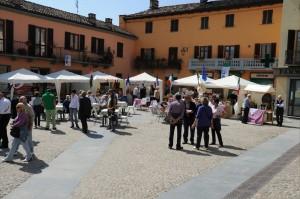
183,91,196,145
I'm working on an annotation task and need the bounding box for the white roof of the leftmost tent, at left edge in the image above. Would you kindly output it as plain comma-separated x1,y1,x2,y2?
0,68,54,83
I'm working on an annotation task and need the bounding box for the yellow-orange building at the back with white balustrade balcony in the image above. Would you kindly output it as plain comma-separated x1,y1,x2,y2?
120,0,282,84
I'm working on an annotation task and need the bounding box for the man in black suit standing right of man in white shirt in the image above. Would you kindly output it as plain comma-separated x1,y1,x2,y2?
79,91,92,133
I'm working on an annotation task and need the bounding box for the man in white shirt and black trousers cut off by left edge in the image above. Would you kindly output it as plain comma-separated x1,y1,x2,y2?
0,91,11,149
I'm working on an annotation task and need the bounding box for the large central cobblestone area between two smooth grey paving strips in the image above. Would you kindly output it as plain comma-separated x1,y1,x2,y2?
73,112,291,199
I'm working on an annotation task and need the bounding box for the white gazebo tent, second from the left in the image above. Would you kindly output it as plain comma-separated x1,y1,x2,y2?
46,70,90,101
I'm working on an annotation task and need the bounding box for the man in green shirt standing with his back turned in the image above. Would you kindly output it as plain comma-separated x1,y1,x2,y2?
42,89,56,130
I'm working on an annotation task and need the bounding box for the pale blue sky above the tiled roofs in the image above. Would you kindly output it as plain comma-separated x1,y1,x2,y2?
29,0,204,25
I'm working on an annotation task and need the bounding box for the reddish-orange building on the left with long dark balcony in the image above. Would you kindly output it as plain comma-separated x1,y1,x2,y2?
0,0,137,81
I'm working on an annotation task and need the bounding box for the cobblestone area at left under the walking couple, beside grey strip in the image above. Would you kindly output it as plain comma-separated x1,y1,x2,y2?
0,119,84,198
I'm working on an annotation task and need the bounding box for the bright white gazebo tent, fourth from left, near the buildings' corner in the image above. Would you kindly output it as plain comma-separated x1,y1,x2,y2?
129,72,163,102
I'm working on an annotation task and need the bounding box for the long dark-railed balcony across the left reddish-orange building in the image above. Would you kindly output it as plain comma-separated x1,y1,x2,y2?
0,41,113,66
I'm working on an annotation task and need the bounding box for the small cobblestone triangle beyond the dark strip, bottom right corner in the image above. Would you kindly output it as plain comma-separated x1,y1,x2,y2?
252,156,300,199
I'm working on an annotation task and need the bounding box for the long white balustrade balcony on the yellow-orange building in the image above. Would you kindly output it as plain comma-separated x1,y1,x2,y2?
189,58,278,70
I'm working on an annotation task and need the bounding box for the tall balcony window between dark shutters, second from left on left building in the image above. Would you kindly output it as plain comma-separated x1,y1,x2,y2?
34,27,47,57
